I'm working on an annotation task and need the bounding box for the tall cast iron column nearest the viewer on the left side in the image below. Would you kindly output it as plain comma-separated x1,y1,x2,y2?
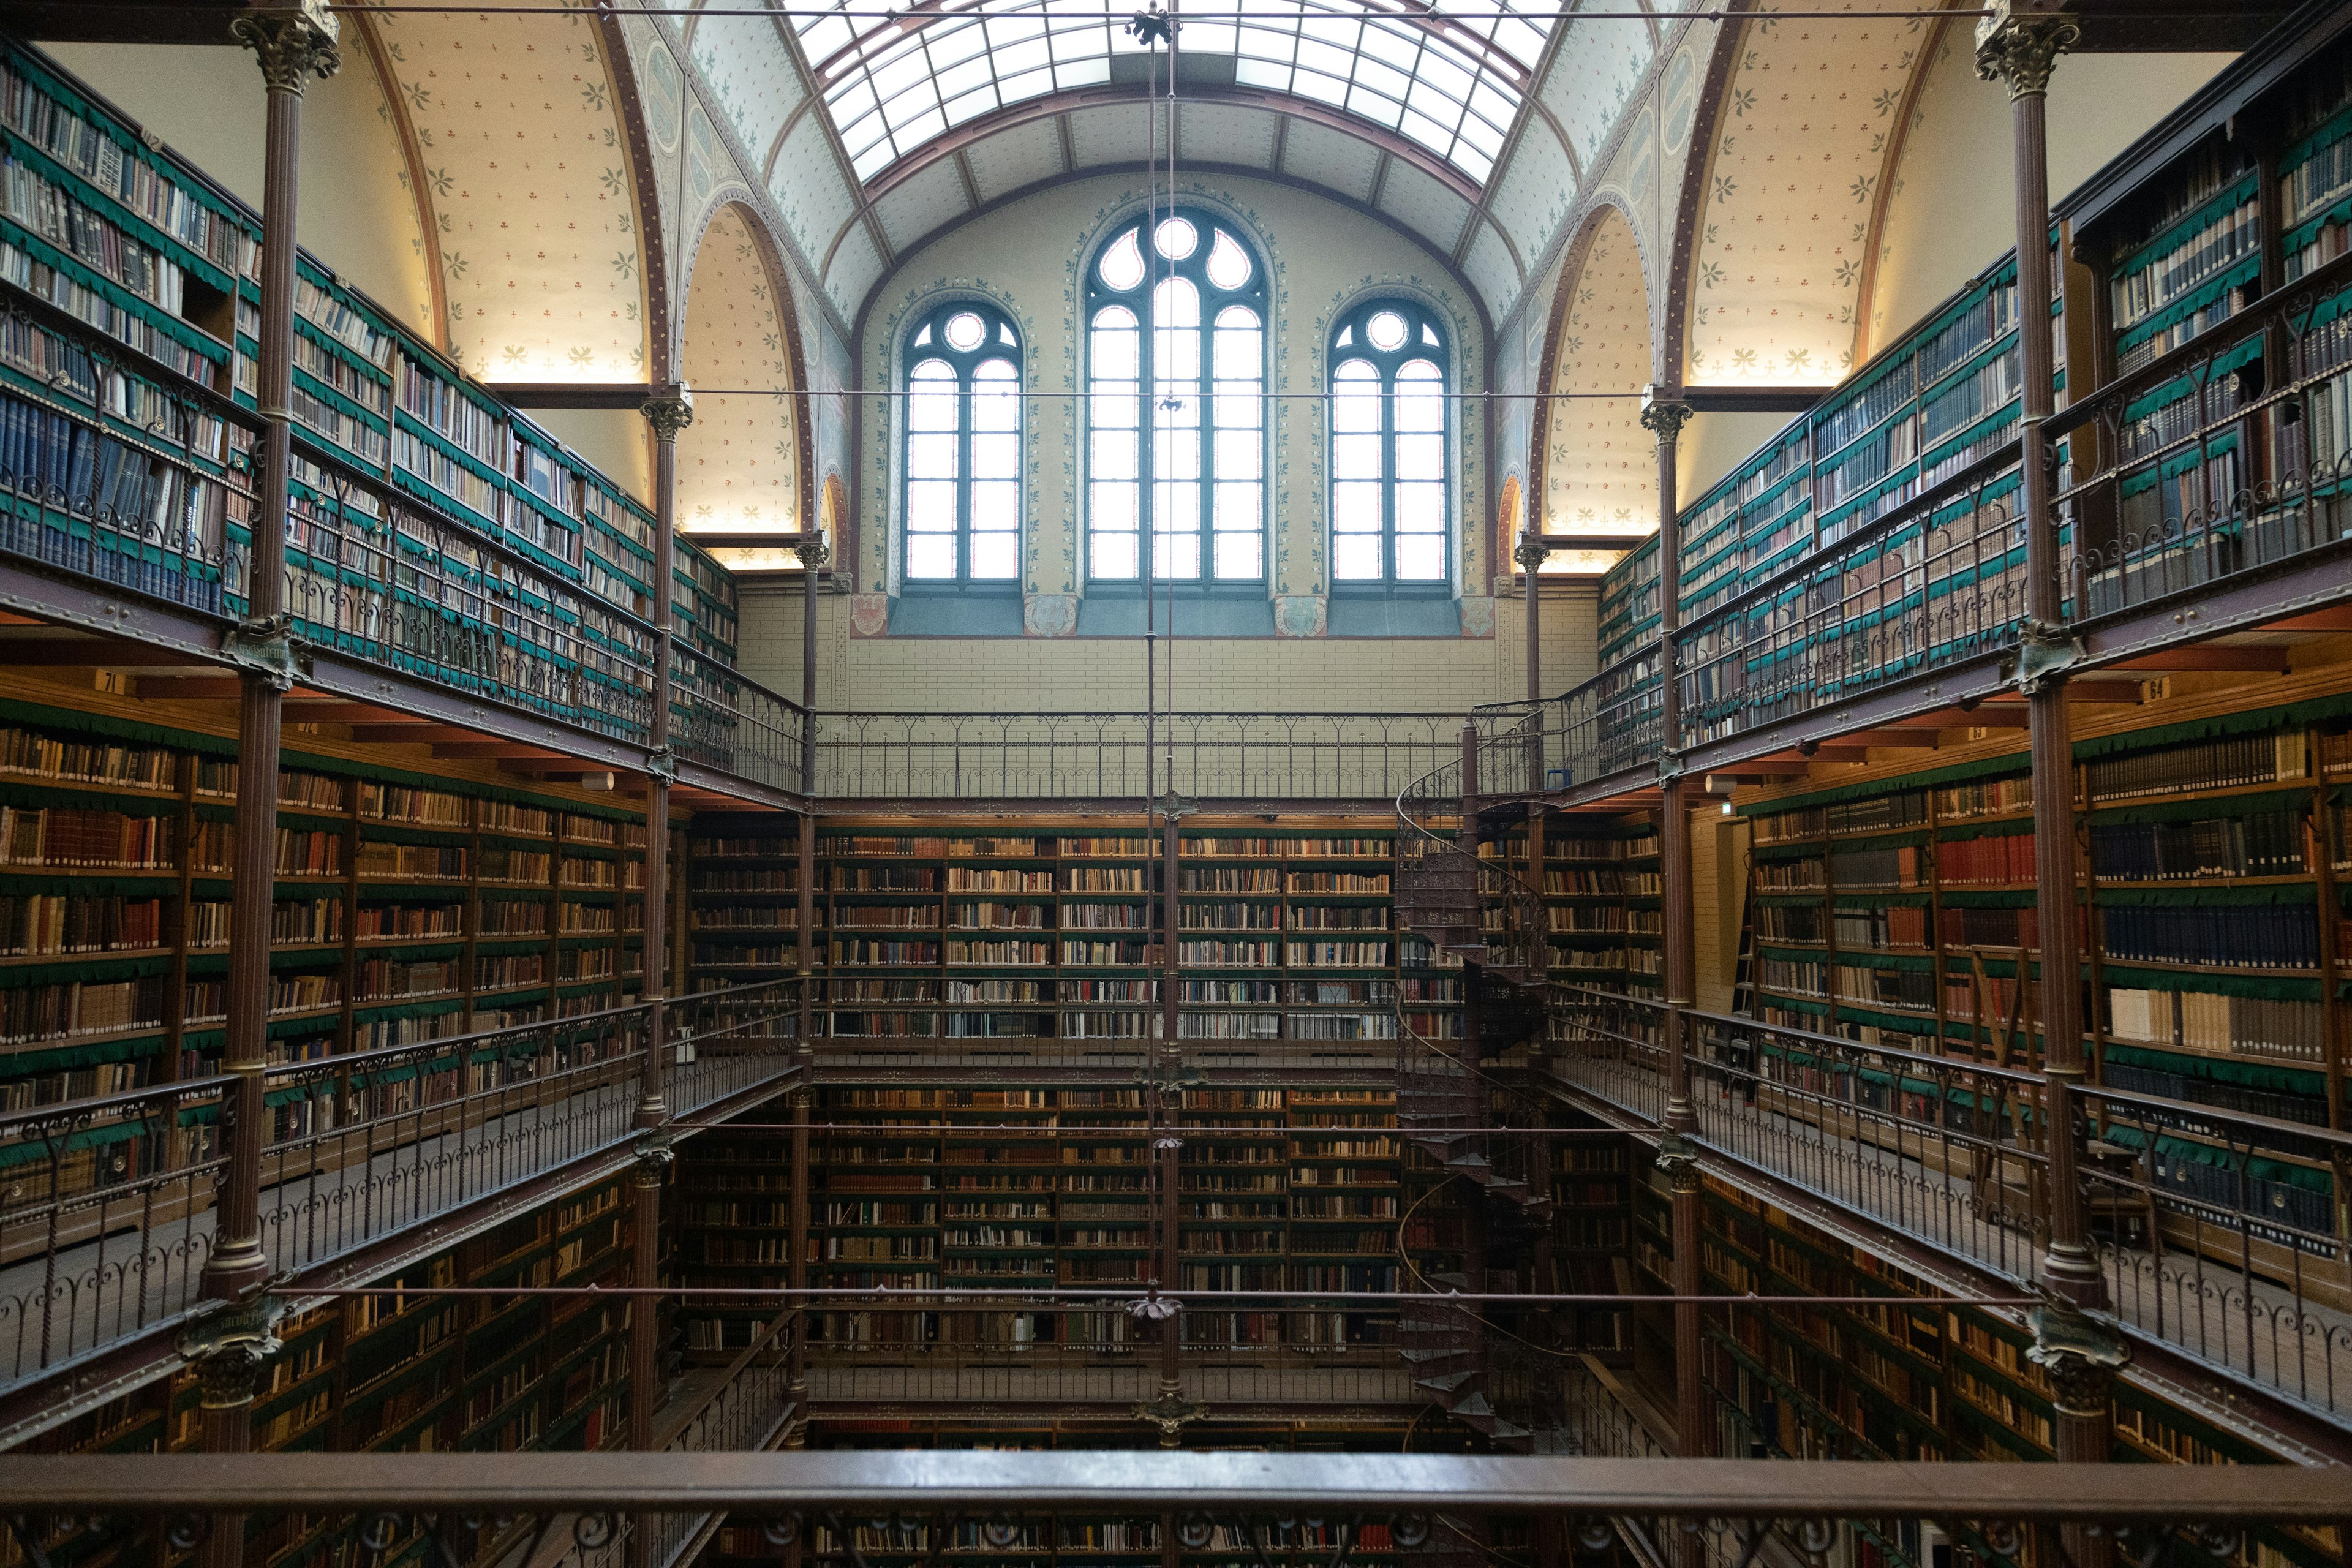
205,7,341,1325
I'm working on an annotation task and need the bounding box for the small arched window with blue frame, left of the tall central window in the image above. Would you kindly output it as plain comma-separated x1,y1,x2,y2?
905,301,1021,583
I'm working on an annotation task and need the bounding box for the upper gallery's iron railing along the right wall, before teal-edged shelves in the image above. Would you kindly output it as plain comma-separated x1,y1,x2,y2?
1477,256,2352,794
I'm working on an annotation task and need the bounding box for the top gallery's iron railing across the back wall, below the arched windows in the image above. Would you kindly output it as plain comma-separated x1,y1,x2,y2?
816,712,1461,802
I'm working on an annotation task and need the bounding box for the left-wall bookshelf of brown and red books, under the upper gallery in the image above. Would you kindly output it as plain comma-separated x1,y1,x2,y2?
0,693,644,1131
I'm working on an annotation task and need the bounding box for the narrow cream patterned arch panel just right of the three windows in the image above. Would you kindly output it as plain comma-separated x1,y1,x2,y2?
1543,211,1658,571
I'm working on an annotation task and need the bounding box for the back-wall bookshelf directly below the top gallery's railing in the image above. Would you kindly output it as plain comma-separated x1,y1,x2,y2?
687,818,1461,1067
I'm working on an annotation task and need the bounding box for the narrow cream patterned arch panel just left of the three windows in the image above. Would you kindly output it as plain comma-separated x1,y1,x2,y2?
677,207,800,533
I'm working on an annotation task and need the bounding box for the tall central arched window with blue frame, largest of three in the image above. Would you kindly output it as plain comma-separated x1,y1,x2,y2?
1087,209,1265,583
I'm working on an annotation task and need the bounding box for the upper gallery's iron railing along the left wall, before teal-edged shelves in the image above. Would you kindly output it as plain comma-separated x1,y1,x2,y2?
0,284,804,792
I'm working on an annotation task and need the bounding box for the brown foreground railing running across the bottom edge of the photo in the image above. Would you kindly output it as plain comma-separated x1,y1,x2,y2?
0,1450,2352,1568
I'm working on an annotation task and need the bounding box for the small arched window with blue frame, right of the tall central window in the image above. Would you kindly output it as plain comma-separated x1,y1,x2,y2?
1331,298,1453,583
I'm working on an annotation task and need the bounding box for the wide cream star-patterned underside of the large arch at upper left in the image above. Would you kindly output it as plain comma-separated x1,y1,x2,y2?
367,3,644,381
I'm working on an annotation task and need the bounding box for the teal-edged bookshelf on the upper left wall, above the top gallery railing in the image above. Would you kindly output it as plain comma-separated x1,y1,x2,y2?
0,45,736,705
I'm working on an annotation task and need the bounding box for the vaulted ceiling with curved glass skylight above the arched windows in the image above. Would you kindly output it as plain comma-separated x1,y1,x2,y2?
682,0,1682,320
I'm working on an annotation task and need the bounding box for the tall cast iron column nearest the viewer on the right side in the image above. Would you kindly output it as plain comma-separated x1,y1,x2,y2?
1976,0,2124,1523
